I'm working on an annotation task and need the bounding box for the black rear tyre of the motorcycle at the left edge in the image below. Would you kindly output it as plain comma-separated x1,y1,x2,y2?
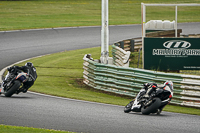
4,80,21,97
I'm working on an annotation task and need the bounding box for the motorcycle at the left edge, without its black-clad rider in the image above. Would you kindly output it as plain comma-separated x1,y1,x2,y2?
0,70,29,97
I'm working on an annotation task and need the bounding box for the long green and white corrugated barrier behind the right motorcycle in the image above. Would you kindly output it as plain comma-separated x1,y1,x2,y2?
83,55,200,108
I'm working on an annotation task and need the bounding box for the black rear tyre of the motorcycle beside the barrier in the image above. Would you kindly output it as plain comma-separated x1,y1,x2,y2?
141,98,161,115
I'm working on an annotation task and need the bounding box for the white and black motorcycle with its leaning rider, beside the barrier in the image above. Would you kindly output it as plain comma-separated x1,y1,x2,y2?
124,81,173,115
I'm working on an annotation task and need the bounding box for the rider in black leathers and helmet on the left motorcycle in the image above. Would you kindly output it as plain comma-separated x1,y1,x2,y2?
7,62,37,93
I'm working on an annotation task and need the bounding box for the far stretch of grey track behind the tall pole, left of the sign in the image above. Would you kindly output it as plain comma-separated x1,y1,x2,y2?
0,25,141,69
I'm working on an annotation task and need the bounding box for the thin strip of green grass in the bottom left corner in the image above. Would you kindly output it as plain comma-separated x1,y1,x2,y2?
0,125,74,133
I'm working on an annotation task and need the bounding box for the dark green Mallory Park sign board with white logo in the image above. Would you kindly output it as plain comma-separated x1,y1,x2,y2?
143,37,200,70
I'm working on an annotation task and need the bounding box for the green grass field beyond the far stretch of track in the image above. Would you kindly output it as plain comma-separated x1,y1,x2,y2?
0,0,200,31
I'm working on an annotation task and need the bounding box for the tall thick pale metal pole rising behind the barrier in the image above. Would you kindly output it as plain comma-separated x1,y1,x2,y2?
101,0,109,64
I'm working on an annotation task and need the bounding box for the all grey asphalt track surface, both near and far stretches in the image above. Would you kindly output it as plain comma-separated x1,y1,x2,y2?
0,23,200,133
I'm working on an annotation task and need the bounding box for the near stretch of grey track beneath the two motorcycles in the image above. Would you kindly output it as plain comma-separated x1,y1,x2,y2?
0,93,200,133
